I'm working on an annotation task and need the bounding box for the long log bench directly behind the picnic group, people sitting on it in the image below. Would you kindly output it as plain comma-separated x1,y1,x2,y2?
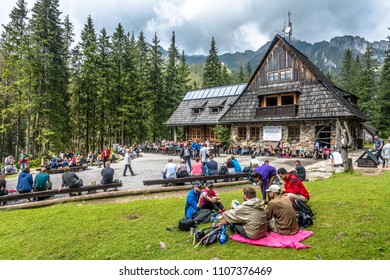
143,173,249,186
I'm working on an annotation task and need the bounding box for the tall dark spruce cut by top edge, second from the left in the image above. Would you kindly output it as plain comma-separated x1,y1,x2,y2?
30,0,69,154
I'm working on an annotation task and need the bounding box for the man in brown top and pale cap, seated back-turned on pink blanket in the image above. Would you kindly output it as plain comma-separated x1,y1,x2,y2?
266,185,299,235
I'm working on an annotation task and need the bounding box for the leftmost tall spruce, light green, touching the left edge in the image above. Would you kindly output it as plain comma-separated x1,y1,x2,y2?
0,0,30,155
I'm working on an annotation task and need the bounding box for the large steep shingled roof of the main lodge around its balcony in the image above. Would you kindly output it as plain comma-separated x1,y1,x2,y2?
220,35,366,123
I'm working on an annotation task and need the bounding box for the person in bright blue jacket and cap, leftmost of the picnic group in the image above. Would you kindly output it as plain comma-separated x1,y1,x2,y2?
184,181,211,225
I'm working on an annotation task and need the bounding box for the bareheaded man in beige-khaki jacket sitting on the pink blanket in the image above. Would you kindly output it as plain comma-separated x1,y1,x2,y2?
218,187,267,240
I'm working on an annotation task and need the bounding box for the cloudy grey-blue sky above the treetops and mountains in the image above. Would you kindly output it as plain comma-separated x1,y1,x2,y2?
0,0,390,54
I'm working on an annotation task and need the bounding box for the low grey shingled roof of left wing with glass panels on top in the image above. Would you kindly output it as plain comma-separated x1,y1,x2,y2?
165,83,246,126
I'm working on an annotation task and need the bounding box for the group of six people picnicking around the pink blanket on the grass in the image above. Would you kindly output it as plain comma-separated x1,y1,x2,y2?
184,164,310,239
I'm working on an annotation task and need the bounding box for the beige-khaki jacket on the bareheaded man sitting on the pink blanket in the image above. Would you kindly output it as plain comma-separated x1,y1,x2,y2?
223,197,267,239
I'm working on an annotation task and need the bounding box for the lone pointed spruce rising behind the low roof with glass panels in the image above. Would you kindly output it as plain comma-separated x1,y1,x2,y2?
203,37,222,87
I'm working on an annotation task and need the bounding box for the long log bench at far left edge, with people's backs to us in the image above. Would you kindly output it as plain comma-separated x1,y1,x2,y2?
0,182,122,205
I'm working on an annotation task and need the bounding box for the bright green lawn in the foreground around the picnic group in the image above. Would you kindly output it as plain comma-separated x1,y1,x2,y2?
0,171,390,260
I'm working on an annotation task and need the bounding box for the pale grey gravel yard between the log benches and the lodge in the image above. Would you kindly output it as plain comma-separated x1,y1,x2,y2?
7,151,370,190
